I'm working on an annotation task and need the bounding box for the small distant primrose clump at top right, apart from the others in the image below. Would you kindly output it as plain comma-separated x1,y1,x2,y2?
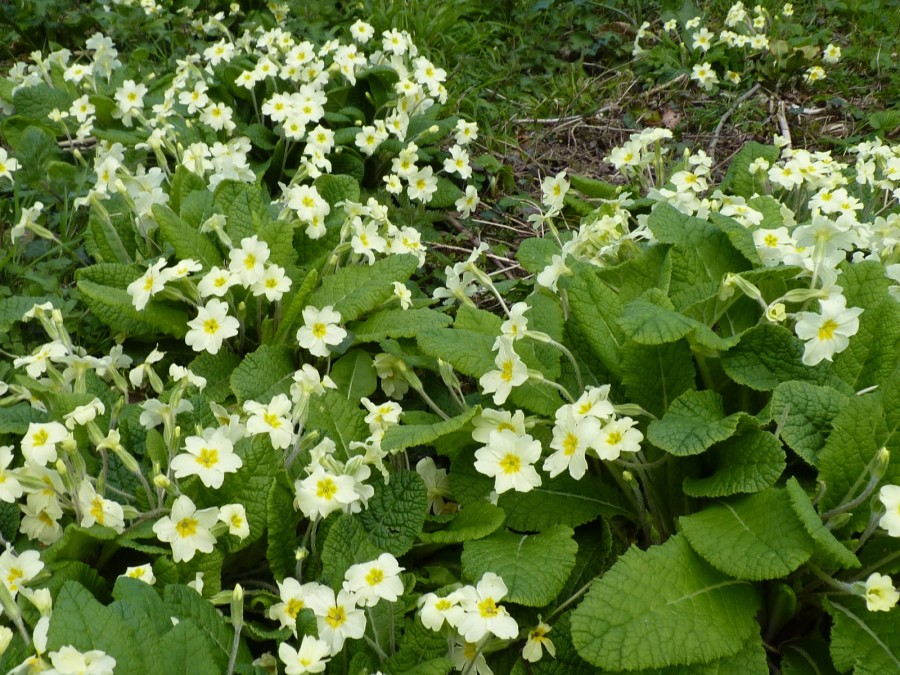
632,2,842,92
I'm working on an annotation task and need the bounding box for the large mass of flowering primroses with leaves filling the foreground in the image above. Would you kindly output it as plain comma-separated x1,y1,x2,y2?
0,3,900,673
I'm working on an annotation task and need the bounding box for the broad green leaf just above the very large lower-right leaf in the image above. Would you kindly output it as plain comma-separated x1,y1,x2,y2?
680,488,814,581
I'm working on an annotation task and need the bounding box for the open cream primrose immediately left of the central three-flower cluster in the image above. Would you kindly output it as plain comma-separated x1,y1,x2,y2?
474,429,541,494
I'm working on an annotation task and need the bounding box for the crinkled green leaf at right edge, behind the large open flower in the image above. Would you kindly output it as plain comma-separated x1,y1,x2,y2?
834,260,900,390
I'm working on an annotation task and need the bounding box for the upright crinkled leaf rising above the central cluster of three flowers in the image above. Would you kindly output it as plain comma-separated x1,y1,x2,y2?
564,266,625,379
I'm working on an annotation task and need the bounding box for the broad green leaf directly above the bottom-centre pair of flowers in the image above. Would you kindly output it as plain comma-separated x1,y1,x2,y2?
462,525,578,607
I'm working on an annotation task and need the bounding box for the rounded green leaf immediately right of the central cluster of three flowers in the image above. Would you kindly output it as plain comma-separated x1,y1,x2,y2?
647,389,747,457
